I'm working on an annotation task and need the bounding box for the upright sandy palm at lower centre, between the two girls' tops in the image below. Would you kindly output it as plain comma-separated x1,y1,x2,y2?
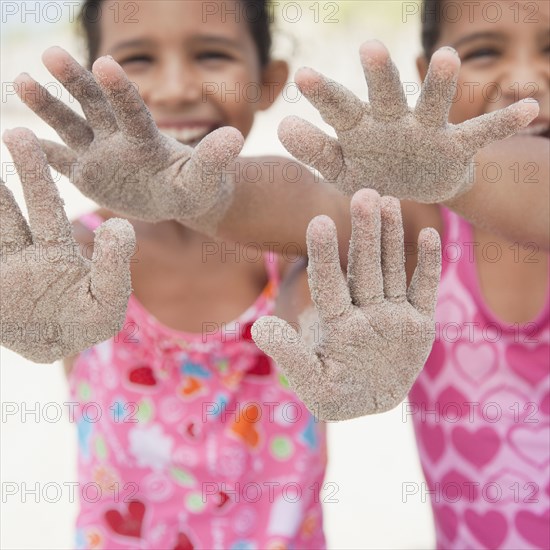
252,190,441,421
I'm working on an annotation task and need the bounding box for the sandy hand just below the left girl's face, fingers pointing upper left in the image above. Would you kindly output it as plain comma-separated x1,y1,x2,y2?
16,47,243,229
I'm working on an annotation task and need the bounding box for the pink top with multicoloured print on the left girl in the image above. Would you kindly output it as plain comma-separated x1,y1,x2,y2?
70,216,326,550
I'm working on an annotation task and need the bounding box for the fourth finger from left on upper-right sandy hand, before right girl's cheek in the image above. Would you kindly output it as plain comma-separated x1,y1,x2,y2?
415,47,460,127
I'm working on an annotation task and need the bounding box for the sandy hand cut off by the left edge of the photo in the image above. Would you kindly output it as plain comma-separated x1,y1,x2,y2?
0,128,135,363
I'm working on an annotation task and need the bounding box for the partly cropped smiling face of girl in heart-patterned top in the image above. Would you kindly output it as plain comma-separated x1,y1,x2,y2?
418,0,550,138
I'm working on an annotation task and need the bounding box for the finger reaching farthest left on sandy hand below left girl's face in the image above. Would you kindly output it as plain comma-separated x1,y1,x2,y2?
15,73,94,153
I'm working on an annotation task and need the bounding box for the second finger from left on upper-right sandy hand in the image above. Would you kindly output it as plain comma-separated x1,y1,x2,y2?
296,68,367,132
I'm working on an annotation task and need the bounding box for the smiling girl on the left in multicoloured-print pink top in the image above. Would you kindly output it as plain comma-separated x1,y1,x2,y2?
9,0,336,550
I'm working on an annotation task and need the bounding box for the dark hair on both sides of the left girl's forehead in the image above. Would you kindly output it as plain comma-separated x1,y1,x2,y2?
78,0,273,67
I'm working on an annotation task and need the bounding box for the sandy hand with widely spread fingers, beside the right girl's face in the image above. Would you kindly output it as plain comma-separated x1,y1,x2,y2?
279,41,538,203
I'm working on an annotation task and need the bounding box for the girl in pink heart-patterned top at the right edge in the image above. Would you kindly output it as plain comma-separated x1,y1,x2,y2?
414,0,550,548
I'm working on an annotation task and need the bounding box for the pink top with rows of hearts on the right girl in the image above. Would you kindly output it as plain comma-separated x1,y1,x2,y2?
412,209,550,550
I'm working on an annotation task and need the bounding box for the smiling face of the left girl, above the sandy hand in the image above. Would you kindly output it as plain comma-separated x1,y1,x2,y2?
98,0,288,145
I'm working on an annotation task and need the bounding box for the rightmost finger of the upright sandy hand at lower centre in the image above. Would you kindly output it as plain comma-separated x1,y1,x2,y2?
407,228,441,317
